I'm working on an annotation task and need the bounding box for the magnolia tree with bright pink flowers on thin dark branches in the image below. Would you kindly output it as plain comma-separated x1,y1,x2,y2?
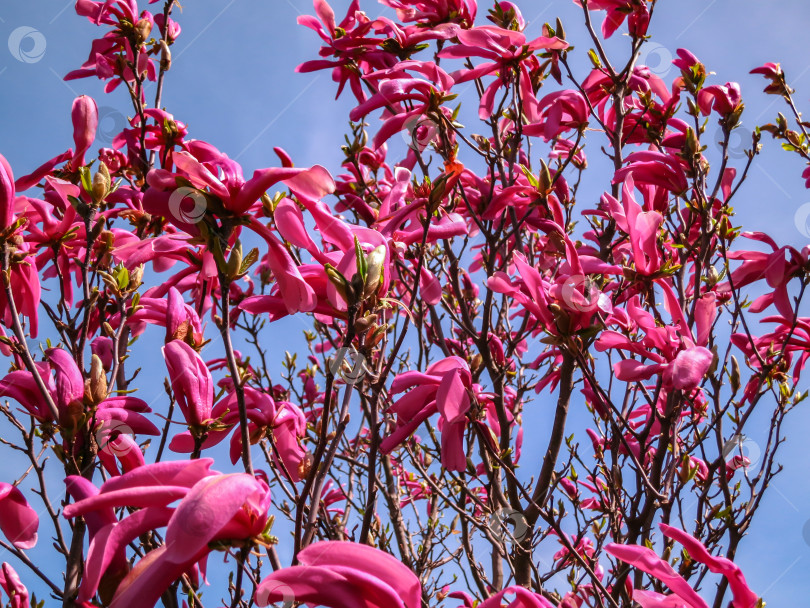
0,0,810,608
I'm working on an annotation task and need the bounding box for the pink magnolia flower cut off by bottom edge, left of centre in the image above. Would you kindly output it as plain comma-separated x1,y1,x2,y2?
255,541,422,608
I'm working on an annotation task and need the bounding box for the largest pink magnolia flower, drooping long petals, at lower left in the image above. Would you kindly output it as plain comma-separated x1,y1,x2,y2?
63,459,270,608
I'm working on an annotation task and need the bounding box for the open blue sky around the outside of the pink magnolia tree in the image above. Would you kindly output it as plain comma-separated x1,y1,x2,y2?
0,0,810,608
